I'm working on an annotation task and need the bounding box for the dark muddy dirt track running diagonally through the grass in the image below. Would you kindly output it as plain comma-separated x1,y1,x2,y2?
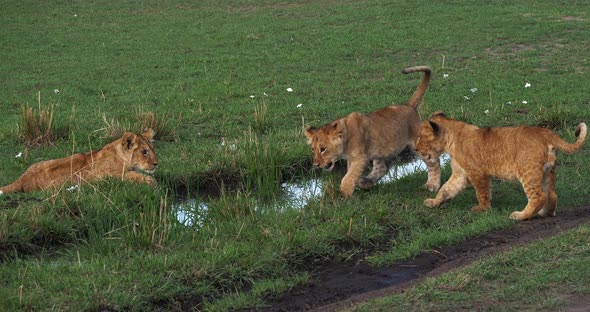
243,206,590,311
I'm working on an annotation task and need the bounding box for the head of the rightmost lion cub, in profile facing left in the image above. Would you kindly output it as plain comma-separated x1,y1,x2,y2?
416,112,445,161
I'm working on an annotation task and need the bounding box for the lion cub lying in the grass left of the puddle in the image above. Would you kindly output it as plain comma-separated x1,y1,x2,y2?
0,129,158,194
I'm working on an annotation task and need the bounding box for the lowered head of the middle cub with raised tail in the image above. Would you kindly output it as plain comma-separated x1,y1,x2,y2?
305,120,345,171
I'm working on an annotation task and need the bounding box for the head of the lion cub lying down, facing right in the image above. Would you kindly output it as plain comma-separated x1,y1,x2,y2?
118,129,158,174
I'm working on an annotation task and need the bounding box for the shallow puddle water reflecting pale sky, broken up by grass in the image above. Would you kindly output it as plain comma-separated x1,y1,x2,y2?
174,154,450,228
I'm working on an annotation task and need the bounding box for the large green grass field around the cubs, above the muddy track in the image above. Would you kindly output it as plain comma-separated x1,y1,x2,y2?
0,0,590,311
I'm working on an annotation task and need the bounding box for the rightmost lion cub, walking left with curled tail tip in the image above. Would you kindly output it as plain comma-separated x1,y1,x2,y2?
416,112,586,220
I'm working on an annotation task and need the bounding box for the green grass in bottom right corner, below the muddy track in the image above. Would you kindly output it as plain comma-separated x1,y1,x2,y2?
350,225,590,312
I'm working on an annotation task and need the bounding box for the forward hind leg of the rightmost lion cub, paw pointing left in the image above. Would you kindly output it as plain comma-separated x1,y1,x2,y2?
510,168,547,220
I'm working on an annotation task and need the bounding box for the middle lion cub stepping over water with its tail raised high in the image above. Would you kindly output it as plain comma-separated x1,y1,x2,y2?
305,66,440,197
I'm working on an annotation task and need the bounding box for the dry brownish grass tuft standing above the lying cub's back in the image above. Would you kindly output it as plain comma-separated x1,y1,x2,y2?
17,92,55,147
